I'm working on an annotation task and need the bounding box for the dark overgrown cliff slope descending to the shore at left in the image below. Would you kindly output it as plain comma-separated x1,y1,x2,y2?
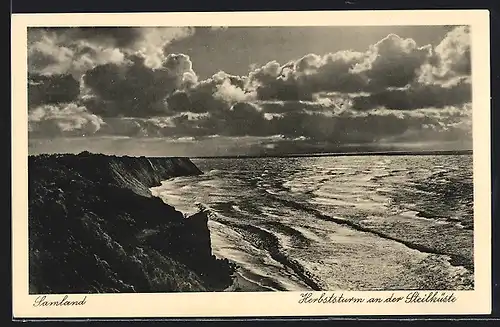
28,153,233,294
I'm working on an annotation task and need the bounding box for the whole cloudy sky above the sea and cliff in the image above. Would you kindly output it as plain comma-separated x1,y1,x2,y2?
28,26,472,156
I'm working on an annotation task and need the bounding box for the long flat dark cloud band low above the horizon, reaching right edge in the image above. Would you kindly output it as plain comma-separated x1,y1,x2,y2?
85,102,472,144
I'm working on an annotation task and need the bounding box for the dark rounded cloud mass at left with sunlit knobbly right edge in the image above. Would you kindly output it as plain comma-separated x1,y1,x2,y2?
83,54,196,117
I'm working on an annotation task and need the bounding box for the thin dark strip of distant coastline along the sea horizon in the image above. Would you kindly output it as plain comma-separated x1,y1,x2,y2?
190,150,472,159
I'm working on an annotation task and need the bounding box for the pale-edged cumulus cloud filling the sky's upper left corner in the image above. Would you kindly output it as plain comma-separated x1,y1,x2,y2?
28,27,193,79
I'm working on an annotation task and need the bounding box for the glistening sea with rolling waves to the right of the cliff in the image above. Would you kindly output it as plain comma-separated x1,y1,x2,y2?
151,154,474,291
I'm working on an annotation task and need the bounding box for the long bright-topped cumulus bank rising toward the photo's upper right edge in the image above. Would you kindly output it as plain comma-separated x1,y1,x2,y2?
247,27,471,109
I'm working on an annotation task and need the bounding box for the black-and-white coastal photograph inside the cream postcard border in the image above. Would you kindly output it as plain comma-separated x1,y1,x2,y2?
12,9,487,318
